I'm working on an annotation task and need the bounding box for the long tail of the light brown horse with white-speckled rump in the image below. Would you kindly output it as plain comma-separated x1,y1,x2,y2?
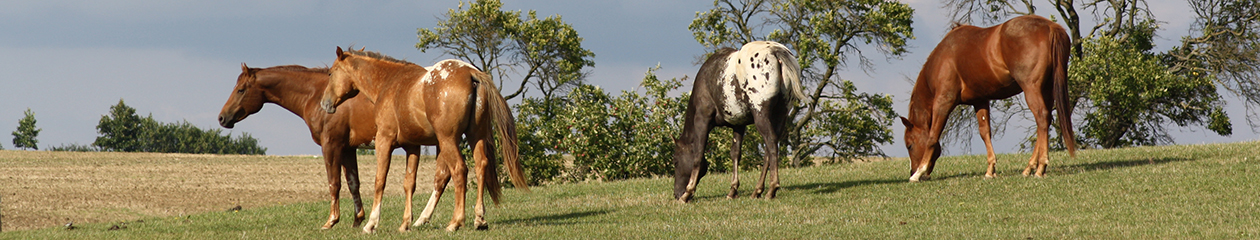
473,71,529,203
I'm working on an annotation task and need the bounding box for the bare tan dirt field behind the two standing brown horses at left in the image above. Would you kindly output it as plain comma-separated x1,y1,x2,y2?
0,150,433,231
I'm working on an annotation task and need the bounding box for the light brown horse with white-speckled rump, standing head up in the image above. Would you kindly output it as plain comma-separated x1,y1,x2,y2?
321,47,528,232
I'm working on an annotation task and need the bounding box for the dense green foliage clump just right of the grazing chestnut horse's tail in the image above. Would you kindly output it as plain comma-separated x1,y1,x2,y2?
1068,30,1232,148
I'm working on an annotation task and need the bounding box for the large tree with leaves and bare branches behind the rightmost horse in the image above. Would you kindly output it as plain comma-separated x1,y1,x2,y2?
945,0,1244,148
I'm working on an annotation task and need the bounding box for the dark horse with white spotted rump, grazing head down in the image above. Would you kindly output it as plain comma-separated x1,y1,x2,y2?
674,42,805,203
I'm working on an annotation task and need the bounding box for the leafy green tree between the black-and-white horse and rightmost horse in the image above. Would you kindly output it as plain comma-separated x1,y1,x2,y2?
688,0,914,165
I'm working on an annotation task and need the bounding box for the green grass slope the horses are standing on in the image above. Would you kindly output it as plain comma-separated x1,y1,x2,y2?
0,141,1260,239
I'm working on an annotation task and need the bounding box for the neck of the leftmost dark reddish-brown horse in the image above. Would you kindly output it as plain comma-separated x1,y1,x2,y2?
258,71,328,119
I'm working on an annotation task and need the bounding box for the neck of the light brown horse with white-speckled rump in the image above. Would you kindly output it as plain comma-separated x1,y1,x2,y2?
358,59,427,101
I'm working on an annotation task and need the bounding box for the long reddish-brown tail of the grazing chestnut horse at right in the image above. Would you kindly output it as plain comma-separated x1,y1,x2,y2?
1050,25,1076,158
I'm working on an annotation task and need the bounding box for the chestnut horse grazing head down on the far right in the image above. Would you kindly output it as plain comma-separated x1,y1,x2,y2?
901,15,1076,182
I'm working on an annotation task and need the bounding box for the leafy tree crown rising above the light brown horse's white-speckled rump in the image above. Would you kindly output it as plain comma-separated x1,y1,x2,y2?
416,0,595,100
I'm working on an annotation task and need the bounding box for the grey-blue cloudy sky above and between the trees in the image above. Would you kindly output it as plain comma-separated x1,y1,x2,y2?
0,0,1256,157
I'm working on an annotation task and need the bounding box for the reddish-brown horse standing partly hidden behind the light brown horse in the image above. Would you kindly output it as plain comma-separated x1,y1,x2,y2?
219,63,377,229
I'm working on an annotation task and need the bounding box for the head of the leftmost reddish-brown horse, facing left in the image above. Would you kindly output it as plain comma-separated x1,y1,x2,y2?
219,63,266,129
